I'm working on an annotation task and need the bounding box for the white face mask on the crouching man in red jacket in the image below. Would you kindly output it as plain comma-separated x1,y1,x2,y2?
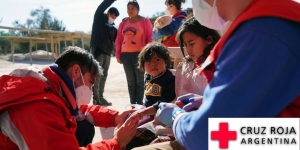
73,70,93,107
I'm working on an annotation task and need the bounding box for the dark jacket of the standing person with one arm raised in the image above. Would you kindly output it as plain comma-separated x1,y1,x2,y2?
90,0,117,56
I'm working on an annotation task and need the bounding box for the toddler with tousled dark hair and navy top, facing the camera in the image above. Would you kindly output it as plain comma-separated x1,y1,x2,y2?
133,42,175,125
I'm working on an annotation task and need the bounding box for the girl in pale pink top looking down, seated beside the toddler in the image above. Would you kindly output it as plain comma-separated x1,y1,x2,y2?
123,17,220,149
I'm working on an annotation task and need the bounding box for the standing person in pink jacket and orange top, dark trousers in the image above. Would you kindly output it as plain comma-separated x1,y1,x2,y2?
116,1,152,104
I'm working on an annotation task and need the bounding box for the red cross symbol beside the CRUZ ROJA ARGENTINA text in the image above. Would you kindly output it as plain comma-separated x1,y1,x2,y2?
211,122,236,149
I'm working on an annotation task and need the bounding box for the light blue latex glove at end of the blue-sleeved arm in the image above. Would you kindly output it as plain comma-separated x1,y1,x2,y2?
156,103,185,127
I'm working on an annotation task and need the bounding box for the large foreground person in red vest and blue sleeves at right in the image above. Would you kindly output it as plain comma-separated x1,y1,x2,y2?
151,0,300,150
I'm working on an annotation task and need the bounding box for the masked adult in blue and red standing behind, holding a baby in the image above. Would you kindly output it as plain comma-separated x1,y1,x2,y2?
157,0,187,47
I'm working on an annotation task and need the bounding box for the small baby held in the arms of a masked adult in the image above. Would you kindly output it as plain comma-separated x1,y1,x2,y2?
152,15,172,42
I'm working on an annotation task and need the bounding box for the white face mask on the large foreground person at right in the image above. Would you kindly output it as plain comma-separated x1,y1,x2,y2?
192,0,228,30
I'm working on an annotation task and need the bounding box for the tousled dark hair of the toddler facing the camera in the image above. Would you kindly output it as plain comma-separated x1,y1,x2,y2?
138,42,171,71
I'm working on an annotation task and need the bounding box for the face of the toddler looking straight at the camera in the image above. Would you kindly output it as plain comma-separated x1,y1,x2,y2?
144,53,167,77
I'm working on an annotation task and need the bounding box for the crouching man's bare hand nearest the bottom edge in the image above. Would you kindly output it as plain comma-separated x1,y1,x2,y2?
114,116,138,148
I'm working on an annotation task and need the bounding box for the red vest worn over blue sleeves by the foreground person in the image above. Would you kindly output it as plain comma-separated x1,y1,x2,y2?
198,0,300,117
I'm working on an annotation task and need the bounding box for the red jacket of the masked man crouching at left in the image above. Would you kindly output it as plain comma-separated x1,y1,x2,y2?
0,68,120,150
